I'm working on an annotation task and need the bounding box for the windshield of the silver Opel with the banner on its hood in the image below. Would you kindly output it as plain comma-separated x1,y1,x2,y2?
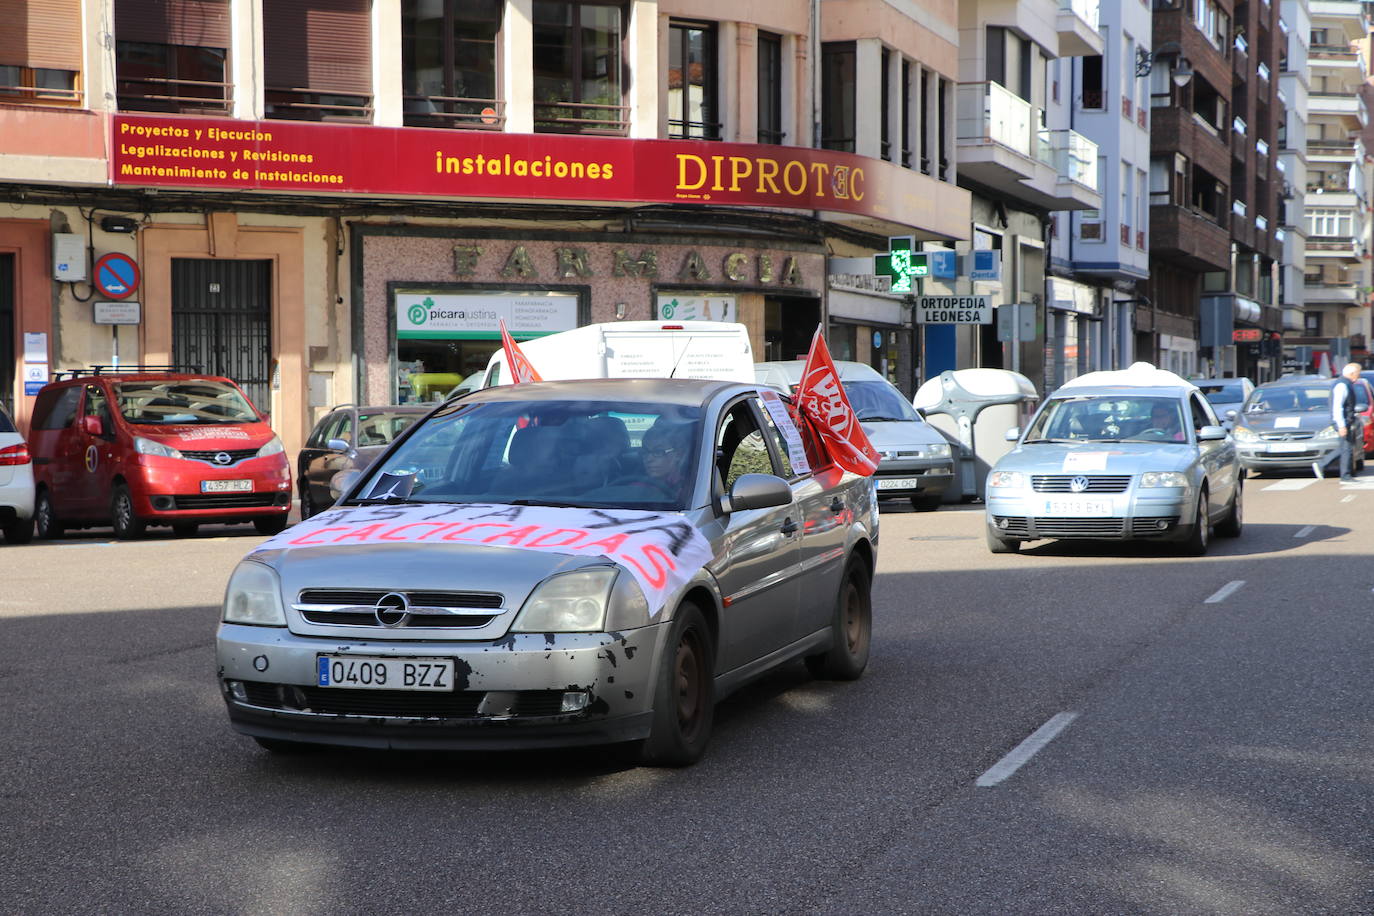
350,400,701,509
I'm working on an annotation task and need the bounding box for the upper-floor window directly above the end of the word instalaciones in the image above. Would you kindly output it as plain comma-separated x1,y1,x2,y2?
533,0,629,133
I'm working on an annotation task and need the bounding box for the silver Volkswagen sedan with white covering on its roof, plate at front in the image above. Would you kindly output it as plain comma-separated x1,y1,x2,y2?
987,368,1242,555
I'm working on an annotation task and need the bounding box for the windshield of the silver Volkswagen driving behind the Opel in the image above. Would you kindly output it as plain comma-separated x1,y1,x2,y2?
1025,396,1187,442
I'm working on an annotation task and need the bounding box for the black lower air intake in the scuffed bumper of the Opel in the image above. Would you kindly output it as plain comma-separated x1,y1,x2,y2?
243,681,563,718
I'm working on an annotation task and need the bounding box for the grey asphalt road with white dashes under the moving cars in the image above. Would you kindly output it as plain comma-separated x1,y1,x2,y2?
0,475,1374,916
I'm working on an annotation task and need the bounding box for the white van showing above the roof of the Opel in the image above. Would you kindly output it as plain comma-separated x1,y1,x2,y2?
481,321,754,389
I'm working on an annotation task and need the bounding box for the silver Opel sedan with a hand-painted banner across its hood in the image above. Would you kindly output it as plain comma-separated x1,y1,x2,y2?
217,379,878,765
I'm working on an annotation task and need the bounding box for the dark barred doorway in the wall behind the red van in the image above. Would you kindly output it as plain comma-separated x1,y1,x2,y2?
172,258,272,413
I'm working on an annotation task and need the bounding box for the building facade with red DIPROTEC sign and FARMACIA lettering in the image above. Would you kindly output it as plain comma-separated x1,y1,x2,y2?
0,0,970,449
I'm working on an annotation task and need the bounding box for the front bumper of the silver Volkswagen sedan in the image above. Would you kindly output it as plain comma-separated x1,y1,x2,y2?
985,488,1197,541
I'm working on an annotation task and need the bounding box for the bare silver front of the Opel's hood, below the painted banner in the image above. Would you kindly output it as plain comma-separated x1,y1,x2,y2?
249,541,609,611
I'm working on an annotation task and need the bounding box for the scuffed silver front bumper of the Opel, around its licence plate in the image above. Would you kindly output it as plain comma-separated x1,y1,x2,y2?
216,623,668,750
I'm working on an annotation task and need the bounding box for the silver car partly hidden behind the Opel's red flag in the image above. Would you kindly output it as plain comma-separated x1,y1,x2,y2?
754,360,955,512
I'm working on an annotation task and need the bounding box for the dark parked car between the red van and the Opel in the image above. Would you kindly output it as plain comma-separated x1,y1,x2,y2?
295,404,433,519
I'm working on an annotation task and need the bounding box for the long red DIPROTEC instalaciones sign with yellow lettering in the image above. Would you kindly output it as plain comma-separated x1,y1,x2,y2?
109,114,925,222
